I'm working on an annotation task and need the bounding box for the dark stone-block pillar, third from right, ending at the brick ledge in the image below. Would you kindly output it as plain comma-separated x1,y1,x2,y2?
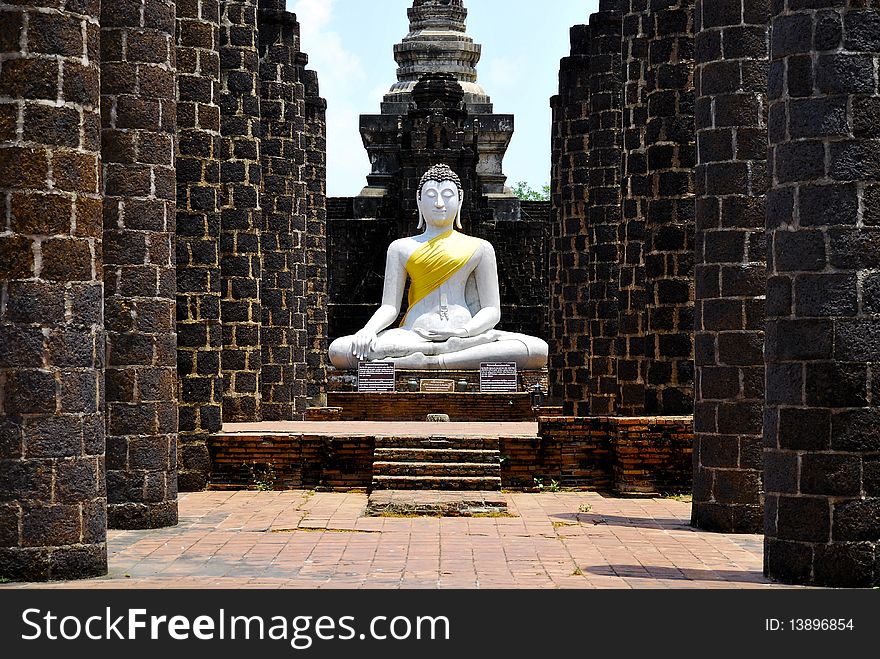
644,0,696,415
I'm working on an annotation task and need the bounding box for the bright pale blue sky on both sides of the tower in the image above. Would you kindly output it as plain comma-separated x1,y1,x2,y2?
287,0,598,197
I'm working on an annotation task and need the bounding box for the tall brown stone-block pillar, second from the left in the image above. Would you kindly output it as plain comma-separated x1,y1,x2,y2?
101,0,177,528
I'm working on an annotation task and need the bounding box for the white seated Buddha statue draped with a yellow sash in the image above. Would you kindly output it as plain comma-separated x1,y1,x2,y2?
330,165,548,370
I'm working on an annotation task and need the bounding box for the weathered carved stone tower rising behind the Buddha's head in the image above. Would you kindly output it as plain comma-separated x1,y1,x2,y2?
361,0,519,217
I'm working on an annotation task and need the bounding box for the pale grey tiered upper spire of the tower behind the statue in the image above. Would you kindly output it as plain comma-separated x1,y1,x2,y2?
383,0,492,114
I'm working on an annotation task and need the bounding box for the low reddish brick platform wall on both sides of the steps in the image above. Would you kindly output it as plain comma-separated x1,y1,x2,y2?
210,417,693,496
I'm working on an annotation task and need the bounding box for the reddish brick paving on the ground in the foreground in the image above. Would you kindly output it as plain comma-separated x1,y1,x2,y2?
0,491,796,589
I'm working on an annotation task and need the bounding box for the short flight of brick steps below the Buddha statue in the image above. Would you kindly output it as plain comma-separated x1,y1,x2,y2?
373,437,501,491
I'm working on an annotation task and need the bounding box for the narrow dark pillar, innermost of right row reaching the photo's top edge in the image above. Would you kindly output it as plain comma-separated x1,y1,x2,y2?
587,0,622,416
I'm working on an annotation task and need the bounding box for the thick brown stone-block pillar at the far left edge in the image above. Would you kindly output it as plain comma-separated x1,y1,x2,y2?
0,2,107,581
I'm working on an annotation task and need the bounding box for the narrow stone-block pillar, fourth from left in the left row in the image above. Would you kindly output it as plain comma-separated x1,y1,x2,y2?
220,0,263,422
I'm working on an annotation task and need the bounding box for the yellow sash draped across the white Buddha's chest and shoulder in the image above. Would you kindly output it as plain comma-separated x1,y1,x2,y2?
403,230,480,323
